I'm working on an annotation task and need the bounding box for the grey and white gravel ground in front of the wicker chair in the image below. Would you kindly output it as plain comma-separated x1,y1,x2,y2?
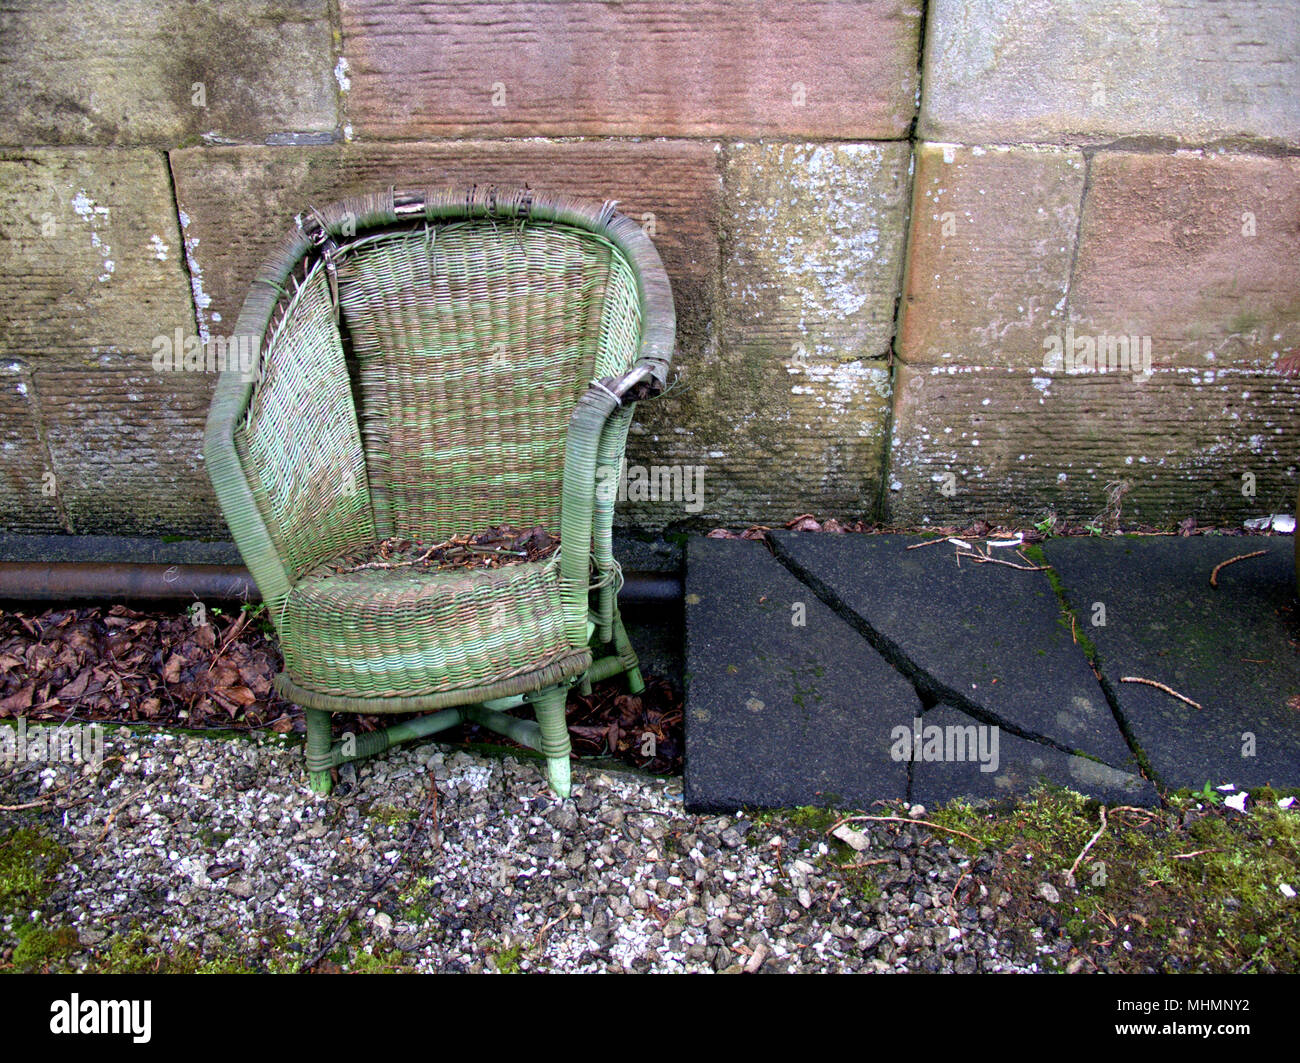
0,729,1066,972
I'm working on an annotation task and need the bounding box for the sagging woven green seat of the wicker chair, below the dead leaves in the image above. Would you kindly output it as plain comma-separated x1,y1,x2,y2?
278,556,592,698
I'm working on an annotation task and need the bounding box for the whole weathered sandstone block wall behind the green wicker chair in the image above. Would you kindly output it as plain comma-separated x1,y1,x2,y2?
0,0,1300,537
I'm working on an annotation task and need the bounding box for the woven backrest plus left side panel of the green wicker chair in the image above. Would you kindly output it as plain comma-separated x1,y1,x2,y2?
235,191,644,577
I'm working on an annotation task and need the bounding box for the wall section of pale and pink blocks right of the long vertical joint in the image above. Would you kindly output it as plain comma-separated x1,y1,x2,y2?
889,0,1300,524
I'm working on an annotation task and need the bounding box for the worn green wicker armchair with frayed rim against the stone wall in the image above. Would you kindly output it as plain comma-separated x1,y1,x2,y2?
204,187,675,797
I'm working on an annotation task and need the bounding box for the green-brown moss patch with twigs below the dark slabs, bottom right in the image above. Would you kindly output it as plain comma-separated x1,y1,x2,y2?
930,789,1300,973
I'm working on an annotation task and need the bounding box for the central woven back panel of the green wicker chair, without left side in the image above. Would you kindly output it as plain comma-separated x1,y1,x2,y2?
338,218,640,542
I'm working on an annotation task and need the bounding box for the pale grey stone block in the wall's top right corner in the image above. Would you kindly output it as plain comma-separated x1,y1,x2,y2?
922,0,1300,144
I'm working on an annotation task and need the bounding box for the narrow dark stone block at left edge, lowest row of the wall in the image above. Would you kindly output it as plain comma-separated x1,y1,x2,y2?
0,363,64,534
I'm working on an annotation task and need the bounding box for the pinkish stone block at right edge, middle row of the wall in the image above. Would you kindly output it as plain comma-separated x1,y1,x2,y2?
1070,152,1300,372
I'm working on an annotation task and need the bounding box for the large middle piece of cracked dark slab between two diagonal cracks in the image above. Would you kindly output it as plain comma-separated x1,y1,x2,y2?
772,530,1135,769
